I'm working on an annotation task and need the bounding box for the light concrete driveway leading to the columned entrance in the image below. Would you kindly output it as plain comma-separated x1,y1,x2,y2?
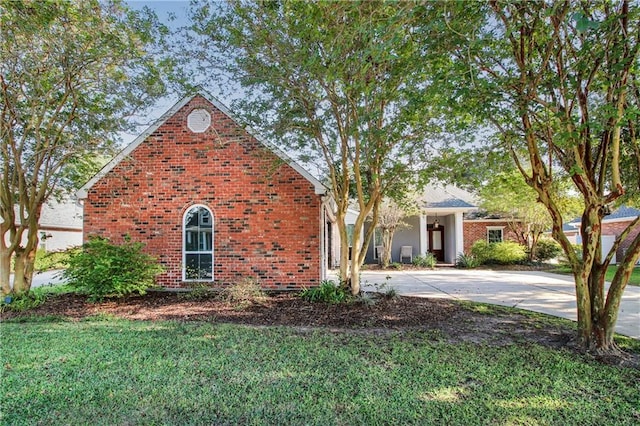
362,268,640,339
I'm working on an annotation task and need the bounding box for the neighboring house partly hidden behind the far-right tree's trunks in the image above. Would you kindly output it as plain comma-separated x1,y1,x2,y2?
565,205,640,263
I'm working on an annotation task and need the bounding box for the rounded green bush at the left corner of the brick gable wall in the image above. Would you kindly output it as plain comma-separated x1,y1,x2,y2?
63,237,163,300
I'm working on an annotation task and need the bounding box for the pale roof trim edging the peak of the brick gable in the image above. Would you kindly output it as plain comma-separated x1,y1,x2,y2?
76,89,326,200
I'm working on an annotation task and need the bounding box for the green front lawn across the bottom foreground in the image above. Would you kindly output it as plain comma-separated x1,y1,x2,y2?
0,317,640,425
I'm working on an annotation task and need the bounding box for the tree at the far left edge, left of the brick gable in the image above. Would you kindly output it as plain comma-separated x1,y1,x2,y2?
0,0,170,295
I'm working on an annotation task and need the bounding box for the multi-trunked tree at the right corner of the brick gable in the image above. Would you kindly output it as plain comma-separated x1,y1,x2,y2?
185,1,456,294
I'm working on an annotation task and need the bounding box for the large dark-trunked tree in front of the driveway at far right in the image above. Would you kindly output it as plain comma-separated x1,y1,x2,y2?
441,0,640,353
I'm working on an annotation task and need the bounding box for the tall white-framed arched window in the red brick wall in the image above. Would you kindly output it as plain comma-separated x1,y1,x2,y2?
182,205,213,281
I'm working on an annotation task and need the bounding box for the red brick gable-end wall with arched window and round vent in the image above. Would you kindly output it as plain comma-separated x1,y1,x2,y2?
78,93,326,290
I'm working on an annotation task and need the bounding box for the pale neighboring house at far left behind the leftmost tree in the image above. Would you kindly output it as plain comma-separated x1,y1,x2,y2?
2,198,82,251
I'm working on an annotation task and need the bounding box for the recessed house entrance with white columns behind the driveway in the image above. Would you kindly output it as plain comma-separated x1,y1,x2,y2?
366,184,516,264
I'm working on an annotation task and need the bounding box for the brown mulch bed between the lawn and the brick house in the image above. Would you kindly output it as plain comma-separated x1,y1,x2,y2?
0,291,640,367
